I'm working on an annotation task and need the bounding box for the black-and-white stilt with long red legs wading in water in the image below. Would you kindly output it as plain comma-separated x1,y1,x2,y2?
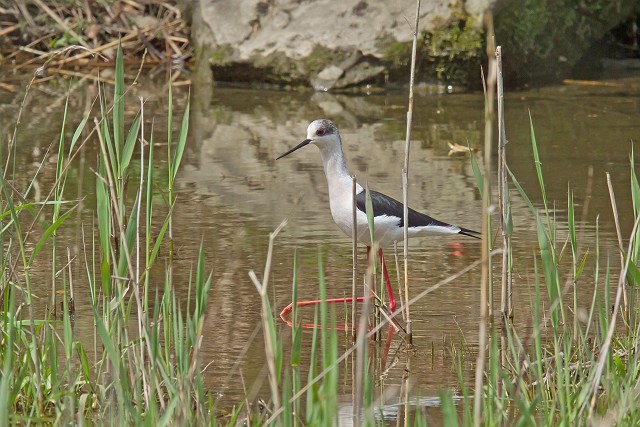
278,119,479,312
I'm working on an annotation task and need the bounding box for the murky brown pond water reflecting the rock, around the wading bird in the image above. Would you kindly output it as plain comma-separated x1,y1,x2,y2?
0,69,640,422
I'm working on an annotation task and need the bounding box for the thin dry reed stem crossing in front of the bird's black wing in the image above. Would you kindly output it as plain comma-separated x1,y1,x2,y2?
402,0,420,346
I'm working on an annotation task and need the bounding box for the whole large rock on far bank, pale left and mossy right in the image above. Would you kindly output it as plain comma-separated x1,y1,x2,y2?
185,0,640,91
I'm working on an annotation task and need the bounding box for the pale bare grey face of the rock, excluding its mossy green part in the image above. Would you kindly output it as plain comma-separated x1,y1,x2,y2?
185,0,496,91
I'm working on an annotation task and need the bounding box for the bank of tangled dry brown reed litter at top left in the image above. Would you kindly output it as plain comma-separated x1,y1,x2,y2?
0,0,193,88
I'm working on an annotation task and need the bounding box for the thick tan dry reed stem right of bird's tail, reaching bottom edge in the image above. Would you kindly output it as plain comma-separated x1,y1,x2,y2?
473,12,497,427
